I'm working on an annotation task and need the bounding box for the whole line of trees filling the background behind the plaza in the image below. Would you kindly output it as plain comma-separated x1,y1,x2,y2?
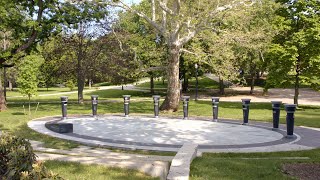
0,0,320,111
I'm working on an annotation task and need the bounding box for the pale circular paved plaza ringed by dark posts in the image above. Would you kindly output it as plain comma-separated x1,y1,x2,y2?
28,115,320,152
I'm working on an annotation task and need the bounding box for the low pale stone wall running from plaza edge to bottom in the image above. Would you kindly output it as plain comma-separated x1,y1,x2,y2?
167,143,198,180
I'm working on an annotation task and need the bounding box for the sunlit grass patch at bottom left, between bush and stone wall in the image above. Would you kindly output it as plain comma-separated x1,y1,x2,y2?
44,161,159,180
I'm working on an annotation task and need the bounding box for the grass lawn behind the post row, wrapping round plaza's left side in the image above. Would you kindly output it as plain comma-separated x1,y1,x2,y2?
0,93,320,149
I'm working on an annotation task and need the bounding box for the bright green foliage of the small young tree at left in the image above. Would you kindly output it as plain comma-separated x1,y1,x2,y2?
17,55,44,98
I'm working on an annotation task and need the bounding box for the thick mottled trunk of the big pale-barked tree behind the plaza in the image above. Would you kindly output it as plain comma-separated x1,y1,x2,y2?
160,44,180,111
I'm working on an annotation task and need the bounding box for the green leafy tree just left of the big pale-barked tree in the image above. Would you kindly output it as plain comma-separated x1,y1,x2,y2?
115,1,167,93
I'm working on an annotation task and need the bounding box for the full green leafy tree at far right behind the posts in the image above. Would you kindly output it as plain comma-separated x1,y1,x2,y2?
268,0,320,104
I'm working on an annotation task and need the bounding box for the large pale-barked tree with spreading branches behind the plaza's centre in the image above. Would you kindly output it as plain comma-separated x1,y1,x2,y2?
104,0,258,111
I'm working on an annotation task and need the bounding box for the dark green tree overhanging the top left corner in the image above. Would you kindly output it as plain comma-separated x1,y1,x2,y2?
0,0,106,110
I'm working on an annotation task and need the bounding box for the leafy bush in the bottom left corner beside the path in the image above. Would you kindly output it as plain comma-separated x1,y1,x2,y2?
0,133,62,180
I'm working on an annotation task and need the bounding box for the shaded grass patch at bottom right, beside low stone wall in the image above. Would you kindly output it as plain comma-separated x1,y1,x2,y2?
190,149,320,180
